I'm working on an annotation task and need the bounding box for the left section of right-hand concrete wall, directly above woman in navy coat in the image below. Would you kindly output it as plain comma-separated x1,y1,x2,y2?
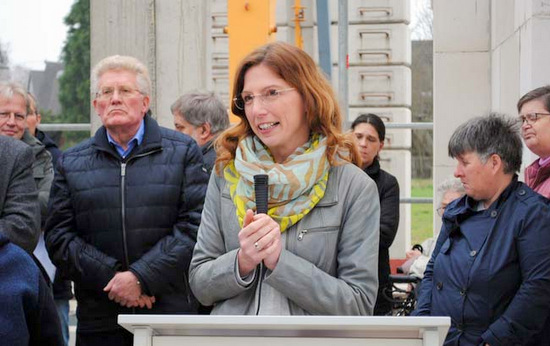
433,0,491,233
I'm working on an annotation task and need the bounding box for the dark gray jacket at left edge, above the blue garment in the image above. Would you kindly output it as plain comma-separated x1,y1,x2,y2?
0,136,40,253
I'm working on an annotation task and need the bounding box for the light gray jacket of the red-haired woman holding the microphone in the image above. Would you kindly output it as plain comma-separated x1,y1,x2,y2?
189,164,380,315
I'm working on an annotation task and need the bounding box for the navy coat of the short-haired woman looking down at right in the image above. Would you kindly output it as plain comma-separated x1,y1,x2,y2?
414,177,550,346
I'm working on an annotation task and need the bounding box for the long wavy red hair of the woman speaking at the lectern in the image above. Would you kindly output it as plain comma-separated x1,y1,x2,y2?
215,42,360,174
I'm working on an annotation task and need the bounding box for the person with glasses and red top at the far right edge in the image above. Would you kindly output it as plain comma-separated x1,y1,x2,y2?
517,85,550,198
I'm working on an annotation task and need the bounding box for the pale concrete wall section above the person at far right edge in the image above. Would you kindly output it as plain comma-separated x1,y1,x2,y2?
491,0,550,166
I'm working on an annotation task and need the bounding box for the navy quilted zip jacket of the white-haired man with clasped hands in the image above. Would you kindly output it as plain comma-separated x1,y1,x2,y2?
46,116,208,332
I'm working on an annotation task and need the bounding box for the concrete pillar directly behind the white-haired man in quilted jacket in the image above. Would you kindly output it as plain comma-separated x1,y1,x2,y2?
90,0,211,133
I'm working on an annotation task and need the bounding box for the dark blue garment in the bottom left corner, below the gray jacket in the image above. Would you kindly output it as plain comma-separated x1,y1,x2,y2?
0,234,63,346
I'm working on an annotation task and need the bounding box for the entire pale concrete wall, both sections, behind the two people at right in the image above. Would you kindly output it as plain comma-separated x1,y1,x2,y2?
433,0,550,232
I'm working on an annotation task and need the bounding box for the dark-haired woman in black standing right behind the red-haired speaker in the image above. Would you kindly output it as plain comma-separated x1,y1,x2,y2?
351,114,399,315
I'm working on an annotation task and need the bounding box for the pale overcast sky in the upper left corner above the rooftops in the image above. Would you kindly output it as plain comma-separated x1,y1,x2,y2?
0,0,74,70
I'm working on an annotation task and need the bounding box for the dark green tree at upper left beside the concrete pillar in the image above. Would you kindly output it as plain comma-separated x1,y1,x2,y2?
59,0,90,123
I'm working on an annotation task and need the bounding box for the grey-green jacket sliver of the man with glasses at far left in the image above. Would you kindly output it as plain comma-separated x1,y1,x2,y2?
21,130,53,223
